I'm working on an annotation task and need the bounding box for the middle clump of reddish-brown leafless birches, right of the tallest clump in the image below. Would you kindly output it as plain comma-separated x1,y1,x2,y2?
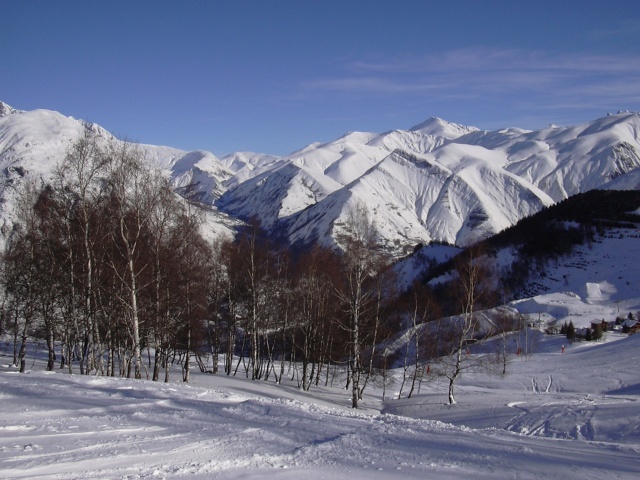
206,205,395,408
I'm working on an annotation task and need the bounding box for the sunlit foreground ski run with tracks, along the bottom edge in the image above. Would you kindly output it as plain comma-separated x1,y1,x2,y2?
0,374,640,480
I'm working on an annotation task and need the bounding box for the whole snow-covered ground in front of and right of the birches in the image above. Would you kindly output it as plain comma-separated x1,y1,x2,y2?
0,333,640,480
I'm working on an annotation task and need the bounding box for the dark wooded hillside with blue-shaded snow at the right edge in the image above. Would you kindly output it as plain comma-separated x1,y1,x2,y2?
484,190,640,303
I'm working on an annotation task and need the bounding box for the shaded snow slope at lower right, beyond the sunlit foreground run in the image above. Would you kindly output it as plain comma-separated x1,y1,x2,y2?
384,333,640,444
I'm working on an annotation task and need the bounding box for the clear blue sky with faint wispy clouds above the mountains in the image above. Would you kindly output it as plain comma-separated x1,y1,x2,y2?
0,0,640,156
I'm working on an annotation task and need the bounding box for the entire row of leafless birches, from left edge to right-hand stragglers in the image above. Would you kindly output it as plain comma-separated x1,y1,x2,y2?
0,132,524,408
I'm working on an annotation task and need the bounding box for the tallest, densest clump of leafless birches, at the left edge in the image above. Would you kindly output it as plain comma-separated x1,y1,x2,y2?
1,132,208,379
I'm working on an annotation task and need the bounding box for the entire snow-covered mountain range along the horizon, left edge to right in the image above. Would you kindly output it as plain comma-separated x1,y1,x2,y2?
0,102,640,256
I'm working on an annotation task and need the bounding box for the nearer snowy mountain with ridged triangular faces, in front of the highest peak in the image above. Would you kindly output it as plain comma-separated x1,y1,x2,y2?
278,146,553,253
